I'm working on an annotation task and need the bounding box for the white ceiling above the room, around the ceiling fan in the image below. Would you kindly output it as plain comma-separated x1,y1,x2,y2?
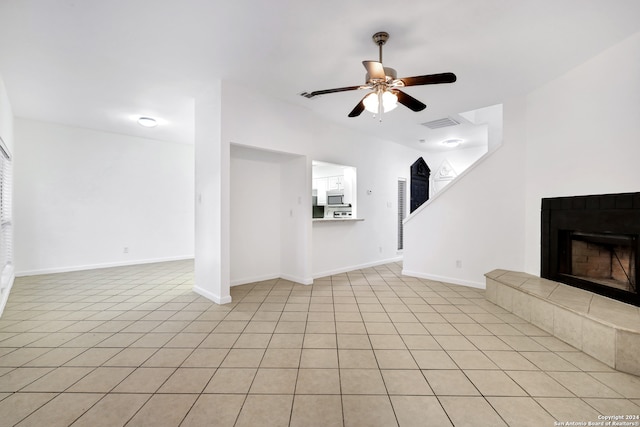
0,0,640,151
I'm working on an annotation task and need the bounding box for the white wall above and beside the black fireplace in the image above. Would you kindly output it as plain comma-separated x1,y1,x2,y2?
525,33,640,274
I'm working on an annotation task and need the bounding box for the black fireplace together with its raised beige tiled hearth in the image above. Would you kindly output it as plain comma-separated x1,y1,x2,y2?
486,193,640,375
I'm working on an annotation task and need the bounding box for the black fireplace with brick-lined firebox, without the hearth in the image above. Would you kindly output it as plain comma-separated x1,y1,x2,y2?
541,193,640,306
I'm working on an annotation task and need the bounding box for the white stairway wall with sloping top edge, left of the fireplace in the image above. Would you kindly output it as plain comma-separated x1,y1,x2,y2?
403,100,525,287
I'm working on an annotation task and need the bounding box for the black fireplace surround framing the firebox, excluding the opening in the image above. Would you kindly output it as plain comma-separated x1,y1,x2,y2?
540,193,640,307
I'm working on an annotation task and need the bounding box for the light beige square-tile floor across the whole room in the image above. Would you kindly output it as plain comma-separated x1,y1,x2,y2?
0,261,640,427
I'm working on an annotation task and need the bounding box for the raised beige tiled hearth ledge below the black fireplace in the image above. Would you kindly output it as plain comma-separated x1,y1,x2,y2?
485,270,640,375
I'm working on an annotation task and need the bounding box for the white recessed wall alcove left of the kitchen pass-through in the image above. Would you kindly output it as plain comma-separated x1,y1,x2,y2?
230,145,312,285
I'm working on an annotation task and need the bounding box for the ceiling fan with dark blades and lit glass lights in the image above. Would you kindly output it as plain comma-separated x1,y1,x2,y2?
301,31,456,121
